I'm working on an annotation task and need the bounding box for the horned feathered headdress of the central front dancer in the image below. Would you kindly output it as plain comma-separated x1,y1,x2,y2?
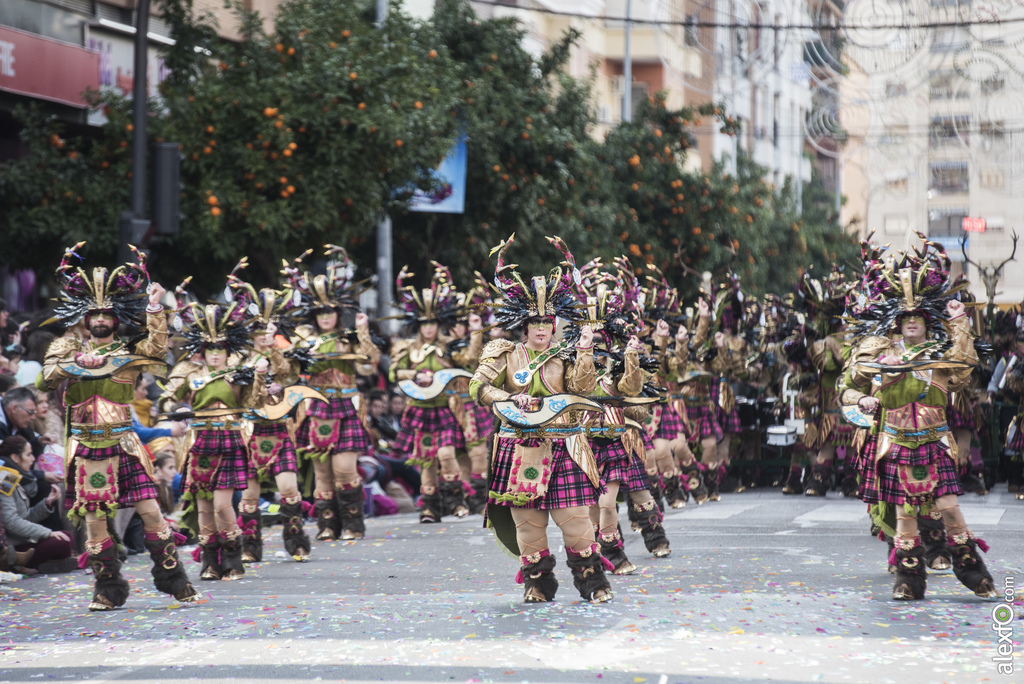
490,233,583,330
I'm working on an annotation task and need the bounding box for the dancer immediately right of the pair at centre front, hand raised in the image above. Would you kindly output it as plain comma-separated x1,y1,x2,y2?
645,265,708,508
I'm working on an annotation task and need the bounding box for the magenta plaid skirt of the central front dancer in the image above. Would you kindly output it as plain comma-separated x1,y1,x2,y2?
487,437,598,510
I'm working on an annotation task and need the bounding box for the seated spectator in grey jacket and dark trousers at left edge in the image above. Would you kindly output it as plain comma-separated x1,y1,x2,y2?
0,435,78,574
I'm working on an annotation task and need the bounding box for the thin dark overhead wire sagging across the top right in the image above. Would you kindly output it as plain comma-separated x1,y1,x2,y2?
470,0,1024,32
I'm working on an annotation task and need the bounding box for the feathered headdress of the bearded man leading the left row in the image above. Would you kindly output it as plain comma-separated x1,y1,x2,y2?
47,242,150,328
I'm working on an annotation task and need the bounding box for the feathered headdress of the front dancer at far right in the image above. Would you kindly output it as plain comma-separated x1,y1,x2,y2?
854,232,965,339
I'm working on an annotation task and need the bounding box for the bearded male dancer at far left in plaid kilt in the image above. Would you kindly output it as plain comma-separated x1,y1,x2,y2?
42,243,199,610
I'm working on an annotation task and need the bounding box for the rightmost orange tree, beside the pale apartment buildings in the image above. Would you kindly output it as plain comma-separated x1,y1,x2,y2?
593,93,856,299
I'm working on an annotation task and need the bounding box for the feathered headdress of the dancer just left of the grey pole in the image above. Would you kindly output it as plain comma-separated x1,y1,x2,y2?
282,245,361,320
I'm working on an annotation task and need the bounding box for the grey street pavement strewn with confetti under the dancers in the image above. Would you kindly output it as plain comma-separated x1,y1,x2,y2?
0,484,1024,684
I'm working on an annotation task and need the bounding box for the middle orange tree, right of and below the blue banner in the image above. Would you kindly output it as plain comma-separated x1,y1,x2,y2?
378,0,614,282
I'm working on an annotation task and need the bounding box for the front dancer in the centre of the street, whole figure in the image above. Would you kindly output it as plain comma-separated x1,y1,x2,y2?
470,236,612,603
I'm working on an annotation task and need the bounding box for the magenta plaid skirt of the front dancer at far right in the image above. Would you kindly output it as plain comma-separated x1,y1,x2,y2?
860,441,964,506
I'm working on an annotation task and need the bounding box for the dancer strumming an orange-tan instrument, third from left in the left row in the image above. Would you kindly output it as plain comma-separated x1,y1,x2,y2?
231,276,310,563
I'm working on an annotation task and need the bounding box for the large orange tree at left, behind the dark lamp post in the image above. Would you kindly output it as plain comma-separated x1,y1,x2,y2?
0,0,458,289
